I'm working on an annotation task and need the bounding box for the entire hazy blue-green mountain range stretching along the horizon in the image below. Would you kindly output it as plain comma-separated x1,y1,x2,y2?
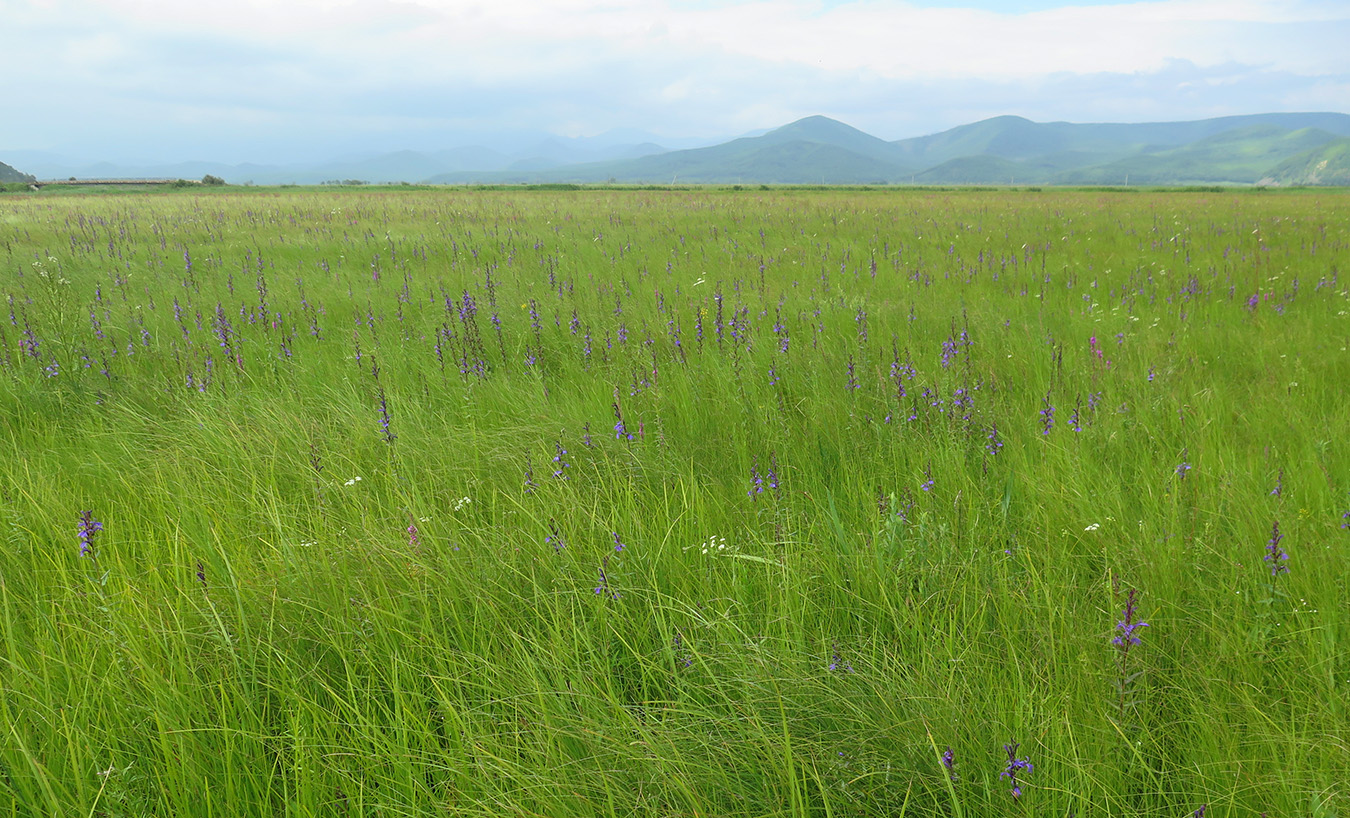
7,113,1350,185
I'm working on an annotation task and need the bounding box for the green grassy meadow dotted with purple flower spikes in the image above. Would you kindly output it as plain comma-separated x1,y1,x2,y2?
0,189,1350,818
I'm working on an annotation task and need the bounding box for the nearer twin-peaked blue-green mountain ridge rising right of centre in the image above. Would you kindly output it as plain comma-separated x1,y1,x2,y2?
429,113,1350,185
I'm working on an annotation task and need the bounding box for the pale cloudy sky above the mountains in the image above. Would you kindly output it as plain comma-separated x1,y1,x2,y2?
0,0,1350,162
